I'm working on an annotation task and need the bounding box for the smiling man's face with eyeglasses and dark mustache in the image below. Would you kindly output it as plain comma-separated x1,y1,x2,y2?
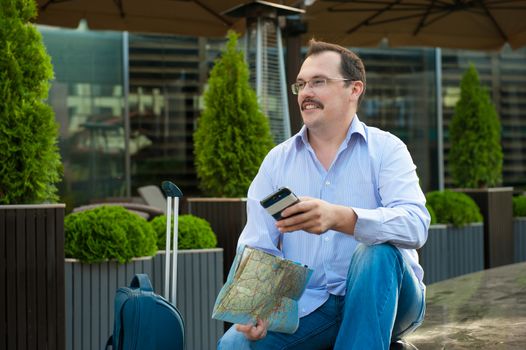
296,51,356,129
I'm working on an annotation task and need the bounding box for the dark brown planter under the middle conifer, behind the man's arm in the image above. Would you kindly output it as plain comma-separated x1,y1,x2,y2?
185,198,247,282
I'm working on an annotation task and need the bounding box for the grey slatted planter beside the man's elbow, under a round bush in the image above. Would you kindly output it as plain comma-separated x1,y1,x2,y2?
419,223,484,284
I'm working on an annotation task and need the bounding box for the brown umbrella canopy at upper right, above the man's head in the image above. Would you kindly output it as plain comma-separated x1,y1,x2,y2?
305,0,526,50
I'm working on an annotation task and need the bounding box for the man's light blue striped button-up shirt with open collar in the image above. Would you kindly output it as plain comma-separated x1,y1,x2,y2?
238,116,430,317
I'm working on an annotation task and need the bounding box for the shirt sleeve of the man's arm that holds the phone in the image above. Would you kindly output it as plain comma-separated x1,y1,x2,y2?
353,137,431,249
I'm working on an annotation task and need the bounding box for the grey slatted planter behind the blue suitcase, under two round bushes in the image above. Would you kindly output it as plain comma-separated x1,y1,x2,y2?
65,248,223,350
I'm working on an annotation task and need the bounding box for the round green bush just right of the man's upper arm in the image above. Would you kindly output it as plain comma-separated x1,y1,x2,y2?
426,190,482,227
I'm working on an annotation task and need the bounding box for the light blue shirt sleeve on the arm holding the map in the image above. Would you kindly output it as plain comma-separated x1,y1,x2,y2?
238,156,283,257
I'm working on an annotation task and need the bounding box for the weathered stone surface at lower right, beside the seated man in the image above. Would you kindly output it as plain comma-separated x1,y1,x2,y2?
407,263,526,350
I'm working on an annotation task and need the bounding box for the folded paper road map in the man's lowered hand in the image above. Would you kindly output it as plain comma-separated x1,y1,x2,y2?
212,246,312,333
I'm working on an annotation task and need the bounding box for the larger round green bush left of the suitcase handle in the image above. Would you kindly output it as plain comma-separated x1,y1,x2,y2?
64,206,157,263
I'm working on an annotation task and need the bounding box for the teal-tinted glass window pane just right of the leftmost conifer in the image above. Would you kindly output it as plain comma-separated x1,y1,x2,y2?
39,27,126,209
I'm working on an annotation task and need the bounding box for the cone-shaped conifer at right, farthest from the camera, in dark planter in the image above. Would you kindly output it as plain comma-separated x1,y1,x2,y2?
449,64,502,188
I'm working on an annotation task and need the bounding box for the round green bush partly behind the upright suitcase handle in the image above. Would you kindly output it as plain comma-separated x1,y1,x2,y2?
150,215,217,250
